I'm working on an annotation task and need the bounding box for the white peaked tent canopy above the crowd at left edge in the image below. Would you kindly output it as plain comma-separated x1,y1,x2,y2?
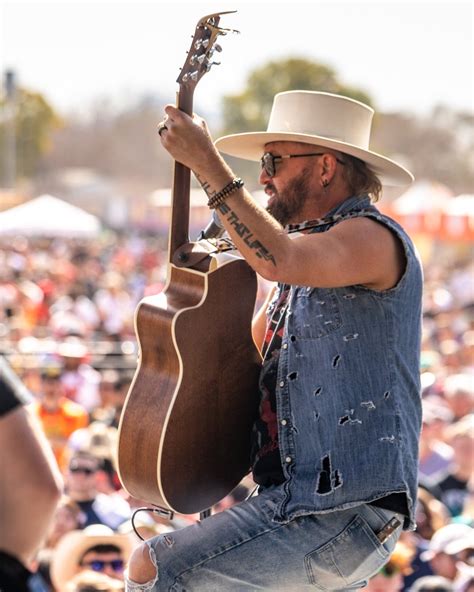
0,195,101,238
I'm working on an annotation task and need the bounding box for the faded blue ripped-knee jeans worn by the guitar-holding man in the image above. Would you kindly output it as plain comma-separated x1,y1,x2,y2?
126,490,403,592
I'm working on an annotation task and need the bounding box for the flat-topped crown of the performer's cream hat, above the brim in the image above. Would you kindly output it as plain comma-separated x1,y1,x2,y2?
267,91,374,150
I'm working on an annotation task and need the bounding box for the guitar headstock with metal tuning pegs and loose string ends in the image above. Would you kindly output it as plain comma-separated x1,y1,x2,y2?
176,10,239,89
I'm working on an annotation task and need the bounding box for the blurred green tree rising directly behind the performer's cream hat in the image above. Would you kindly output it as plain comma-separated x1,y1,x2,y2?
223,57,371,134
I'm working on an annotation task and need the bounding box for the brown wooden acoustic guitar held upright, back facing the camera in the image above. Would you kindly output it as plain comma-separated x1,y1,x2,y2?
118,11,261,514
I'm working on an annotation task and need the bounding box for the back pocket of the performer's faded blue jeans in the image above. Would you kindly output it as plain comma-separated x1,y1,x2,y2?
305,514,389,592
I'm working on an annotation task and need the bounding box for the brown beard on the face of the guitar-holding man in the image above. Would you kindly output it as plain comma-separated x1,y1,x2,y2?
266,170,310,226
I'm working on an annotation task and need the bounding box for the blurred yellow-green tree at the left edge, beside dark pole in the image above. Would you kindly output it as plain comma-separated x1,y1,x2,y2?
0,89,61,178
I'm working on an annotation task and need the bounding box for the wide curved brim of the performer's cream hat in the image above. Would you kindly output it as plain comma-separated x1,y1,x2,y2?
215,132,414,187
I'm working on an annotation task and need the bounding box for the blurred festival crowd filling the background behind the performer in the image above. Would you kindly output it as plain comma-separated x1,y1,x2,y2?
0,235,474,592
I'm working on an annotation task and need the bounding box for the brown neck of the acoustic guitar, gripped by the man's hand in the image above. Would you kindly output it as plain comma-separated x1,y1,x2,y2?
168,87,193,262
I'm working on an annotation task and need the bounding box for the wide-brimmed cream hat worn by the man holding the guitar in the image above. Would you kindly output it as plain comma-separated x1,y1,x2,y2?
215,90,413,187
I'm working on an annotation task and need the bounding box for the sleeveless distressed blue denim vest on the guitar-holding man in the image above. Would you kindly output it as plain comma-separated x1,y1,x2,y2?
274,197,423,529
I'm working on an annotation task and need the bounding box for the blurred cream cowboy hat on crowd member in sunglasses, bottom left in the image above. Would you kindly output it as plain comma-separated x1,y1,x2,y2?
51,524,133,592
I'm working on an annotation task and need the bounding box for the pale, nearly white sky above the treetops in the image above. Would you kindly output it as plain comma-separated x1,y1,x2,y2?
0,0,474,114
